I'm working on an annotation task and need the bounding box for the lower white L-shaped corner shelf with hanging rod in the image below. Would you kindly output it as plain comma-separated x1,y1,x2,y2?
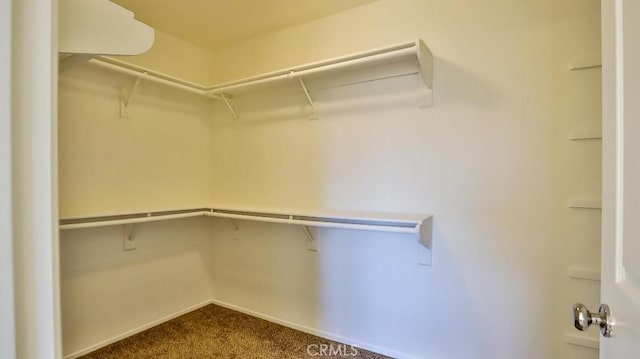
59,206,432,248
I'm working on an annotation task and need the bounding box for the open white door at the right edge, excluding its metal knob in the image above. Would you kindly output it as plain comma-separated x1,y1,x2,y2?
591,0,640,359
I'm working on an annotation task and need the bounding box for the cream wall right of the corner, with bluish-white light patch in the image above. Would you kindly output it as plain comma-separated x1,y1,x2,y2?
205,0,600,359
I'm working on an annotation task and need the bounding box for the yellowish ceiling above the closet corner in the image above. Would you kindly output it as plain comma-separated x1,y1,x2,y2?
112,0,376,50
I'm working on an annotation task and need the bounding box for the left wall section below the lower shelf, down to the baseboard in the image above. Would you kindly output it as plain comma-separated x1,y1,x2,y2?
60,218,212,355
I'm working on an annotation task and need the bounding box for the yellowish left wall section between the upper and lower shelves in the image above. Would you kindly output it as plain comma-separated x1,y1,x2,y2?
60,64,211,218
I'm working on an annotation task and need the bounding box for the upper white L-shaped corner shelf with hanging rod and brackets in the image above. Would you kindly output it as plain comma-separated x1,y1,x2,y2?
74,39,433,119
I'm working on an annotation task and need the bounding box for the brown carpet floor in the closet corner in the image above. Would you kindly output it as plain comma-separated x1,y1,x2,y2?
82,304,388,359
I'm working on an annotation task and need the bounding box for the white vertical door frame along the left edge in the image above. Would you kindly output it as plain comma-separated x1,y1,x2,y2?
8,0,62,359
